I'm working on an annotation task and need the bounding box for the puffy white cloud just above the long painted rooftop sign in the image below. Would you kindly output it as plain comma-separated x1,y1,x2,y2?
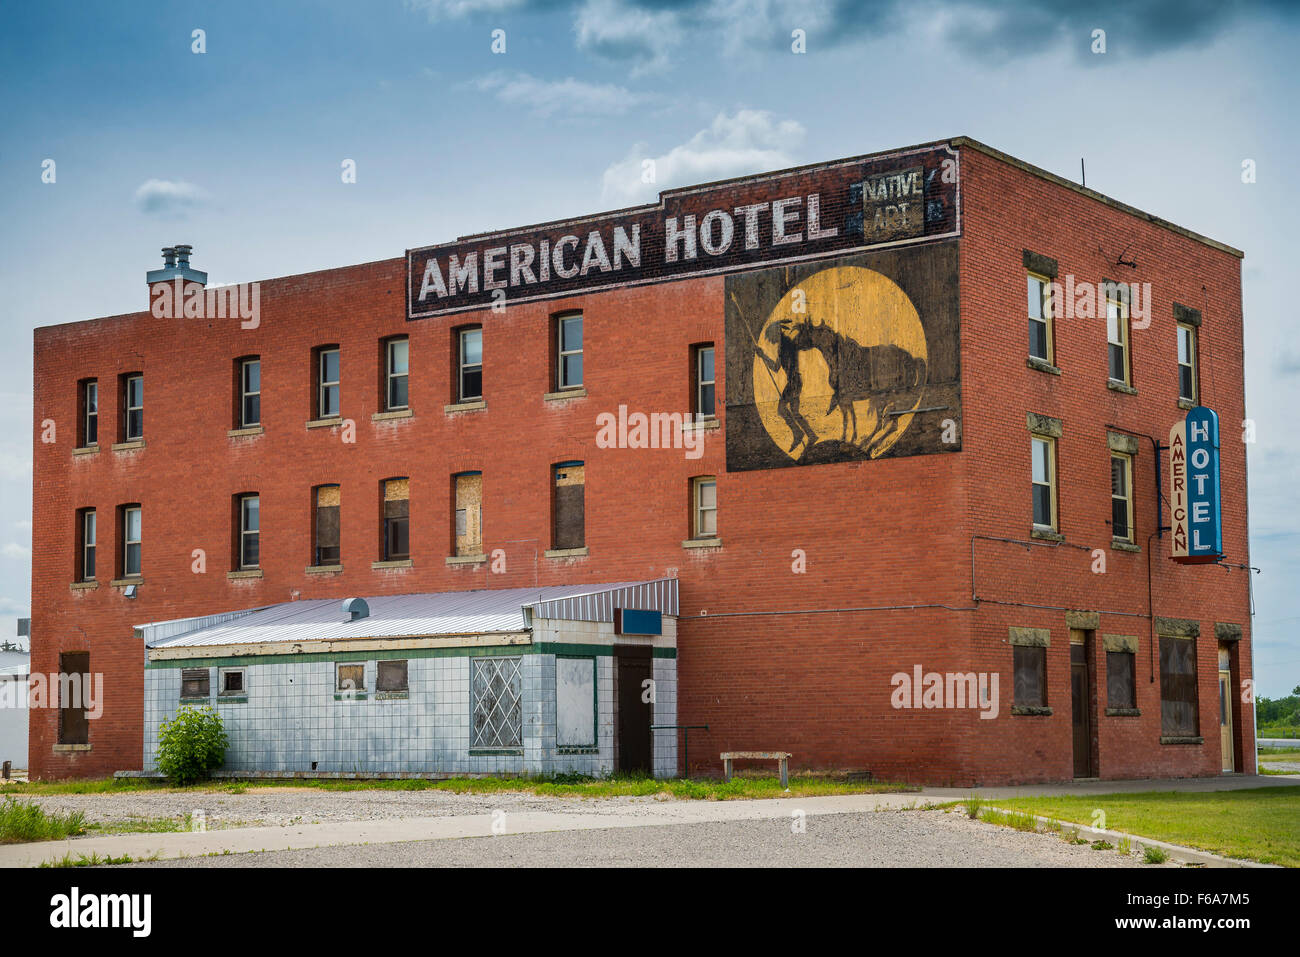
601,109,805,205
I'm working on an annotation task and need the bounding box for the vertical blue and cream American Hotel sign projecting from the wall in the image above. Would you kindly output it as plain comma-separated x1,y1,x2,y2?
1169,406,1223,564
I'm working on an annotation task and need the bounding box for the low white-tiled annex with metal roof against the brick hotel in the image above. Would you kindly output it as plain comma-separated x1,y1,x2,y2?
135,579,677,778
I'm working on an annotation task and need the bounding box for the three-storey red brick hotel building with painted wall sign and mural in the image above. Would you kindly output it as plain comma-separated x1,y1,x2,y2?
30,138,1255,785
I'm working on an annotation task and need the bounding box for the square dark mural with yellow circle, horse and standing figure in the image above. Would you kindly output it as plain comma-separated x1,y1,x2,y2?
725,243,961,471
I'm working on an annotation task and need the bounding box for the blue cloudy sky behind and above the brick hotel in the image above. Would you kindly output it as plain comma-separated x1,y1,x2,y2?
0,0,1300,696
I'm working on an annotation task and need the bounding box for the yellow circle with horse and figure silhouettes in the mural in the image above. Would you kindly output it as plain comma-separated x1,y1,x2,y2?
754,265,928,462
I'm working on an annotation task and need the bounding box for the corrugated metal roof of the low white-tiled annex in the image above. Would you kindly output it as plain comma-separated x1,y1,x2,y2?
135,579,677,648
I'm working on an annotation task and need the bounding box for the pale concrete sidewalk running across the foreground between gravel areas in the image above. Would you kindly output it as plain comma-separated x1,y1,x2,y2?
0,775,1300,867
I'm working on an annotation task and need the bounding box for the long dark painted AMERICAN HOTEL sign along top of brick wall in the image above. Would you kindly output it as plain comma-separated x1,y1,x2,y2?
407,144,961,319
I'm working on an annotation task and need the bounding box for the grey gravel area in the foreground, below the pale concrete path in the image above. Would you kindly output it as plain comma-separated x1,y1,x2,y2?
129,810,1173,867
